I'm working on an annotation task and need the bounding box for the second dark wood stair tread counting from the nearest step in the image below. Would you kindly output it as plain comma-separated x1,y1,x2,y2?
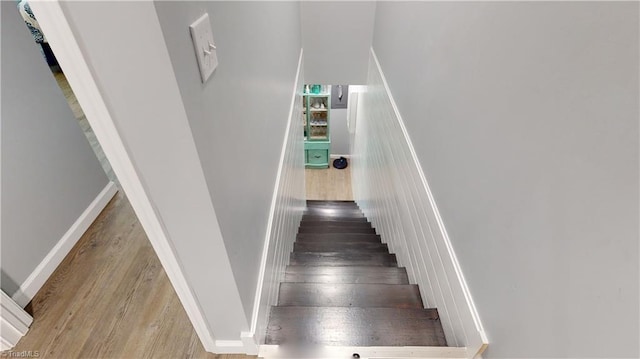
278,282,422,309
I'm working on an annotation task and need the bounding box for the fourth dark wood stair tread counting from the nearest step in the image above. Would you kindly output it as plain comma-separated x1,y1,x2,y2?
290,252,398,267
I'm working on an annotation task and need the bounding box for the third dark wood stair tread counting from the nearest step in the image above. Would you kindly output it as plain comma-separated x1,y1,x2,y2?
285,265,409,284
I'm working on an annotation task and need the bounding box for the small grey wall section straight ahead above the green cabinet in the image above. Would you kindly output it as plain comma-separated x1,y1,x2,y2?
301,1,376,85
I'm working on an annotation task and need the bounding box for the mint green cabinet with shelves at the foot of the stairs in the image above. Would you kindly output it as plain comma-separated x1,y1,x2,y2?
302,93,331,168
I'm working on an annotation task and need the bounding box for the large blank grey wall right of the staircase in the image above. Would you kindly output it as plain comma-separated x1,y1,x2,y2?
373,2,640,358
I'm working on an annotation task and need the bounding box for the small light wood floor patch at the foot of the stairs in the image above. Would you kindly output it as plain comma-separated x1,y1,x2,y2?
305,163,353,201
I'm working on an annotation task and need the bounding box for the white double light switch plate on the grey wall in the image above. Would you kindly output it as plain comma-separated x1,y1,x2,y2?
189,13,218,83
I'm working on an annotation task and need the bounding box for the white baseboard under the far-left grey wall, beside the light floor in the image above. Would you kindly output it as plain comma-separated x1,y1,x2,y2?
12,182,118,308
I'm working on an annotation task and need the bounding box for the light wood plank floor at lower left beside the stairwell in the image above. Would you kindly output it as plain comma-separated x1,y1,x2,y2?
5,193,255,359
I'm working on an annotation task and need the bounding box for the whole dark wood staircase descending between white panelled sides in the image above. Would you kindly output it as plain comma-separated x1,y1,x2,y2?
265,201,447,356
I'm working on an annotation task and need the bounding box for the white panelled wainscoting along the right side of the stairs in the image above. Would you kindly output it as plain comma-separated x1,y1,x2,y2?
352,49,488,357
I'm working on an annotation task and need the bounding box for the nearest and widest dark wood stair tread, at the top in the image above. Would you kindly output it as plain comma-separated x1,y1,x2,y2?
265,307,447,346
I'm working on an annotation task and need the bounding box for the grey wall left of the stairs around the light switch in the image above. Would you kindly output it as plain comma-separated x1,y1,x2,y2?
155,1,301,326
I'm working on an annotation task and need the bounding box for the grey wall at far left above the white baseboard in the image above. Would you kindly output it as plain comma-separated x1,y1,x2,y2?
0,1,109,295
